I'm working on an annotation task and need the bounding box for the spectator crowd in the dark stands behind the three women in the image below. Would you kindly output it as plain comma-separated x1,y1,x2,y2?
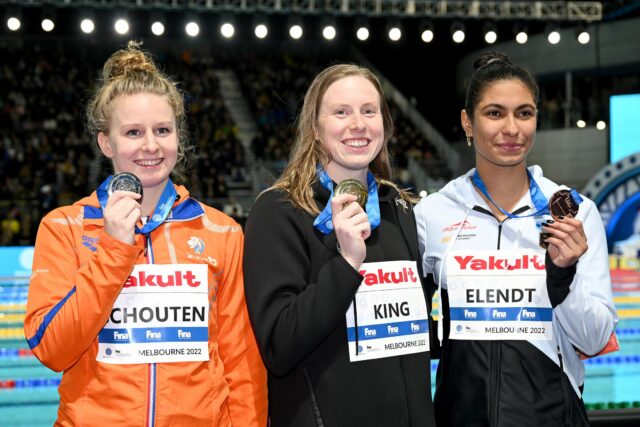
5,40,640,245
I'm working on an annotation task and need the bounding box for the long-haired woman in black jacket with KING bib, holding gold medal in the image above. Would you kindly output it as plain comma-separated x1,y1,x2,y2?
244,64,435,427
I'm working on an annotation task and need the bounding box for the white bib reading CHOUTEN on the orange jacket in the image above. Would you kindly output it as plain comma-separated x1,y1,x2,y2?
97,264,209,364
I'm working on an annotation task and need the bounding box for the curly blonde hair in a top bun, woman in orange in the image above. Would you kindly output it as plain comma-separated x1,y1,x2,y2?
86,41,189,180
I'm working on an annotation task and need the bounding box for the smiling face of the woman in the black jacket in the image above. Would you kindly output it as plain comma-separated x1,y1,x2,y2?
316,75,384,183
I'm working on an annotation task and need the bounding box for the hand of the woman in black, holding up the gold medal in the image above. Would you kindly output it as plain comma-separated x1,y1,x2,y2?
331,194,371,270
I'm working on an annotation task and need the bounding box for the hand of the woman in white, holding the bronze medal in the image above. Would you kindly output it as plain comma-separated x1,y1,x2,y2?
544,218,589,267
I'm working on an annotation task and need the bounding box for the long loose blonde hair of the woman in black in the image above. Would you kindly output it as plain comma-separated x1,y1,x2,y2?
267,64,415,215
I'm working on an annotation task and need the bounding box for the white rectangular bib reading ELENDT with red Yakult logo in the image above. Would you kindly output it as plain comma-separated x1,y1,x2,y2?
447,249,553,340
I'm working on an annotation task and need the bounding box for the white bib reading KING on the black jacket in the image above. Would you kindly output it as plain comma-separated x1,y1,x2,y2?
346,261,429,362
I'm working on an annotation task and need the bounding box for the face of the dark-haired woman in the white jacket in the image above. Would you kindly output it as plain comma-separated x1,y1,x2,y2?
461,80,537,168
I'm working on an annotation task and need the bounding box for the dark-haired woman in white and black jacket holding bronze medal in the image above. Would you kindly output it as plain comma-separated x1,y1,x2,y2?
415,52,617,427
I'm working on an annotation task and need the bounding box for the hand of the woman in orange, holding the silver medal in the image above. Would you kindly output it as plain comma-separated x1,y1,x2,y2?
104,191,142,245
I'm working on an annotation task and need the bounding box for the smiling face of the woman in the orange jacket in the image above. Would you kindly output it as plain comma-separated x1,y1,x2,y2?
98,93,178,194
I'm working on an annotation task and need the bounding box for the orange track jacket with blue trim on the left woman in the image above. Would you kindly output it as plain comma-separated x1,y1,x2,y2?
25,186,267,427
